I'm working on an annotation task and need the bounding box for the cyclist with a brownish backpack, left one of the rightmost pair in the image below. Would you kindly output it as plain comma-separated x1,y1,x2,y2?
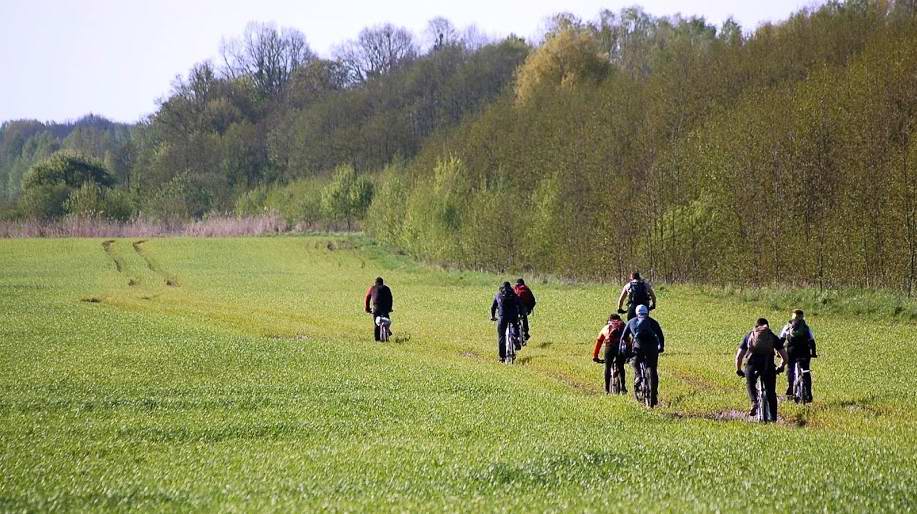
736,318,787,421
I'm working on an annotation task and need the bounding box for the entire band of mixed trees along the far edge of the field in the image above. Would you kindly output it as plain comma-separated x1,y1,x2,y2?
0,0,917,292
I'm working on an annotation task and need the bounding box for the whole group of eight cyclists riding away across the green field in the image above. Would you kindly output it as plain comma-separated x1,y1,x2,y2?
364,272,818,421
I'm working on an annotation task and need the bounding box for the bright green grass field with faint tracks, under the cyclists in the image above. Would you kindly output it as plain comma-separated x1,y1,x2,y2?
0,237,917,512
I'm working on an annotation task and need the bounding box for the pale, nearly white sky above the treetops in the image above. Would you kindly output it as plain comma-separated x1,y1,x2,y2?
0,0,812,122
